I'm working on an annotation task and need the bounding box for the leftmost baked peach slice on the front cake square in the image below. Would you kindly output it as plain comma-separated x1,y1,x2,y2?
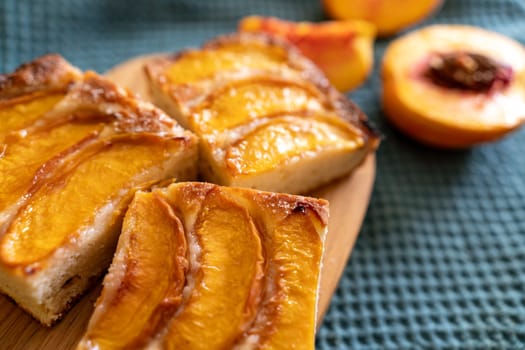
79,192,187,349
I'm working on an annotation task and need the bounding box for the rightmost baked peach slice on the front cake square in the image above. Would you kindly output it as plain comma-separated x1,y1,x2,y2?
236,202,323,349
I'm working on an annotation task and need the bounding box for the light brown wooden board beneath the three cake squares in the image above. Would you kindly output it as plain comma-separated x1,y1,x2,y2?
0,56,375,350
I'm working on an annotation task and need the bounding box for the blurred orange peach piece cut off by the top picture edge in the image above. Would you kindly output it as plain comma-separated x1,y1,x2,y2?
323,0,443,36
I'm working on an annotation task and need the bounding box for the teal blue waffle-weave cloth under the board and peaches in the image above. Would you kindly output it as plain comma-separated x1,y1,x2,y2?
0,0,525,349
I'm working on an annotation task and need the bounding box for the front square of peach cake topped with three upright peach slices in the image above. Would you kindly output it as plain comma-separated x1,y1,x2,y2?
78,182,328,350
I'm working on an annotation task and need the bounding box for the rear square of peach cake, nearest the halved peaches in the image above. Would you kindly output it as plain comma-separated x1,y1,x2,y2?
145,33,379,194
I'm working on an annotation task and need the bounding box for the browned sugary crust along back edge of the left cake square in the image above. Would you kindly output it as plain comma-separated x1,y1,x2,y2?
0,54,184,137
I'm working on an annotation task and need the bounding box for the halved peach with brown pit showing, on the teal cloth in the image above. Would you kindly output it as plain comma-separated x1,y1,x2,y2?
382,25,525,148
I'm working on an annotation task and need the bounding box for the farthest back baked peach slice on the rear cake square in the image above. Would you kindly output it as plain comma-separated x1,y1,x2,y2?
166,42,287,84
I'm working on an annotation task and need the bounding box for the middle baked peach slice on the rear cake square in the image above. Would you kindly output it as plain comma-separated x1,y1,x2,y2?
191,78,324,133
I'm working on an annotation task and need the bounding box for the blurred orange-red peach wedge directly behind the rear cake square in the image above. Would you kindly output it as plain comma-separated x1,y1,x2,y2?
239,16,375,92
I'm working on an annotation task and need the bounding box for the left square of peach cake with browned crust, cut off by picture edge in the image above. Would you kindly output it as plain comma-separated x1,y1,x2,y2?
0,55,198,325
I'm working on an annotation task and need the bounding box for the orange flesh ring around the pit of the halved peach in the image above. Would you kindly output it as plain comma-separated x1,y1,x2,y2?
382,26,525,148
